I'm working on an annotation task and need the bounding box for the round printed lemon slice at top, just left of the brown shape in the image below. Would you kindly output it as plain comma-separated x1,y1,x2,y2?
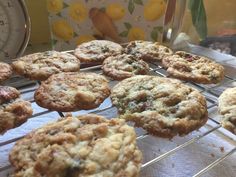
69,2,88,23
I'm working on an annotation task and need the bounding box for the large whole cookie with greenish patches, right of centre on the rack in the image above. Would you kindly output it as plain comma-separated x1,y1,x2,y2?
111,75,208,138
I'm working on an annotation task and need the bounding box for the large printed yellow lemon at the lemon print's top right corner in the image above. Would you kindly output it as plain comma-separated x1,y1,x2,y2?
144,0,166,21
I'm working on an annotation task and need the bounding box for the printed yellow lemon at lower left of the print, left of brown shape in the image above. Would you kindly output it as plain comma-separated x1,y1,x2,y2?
52,20,74,41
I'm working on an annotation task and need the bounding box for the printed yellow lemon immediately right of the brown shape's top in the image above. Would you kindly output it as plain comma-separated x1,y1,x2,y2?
106,3,125,21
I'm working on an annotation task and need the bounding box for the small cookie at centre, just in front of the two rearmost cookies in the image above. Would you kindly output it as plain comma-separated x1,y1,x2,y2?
102,54,149,80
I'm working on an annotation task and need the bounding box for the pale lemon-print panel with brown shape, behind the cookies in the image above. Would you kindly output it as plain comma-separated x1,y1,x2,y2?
47,0,167,50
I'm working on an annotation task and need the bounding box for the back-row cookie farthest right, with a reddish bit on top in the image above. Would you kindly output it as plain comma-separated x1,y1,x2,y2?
163,51,224,84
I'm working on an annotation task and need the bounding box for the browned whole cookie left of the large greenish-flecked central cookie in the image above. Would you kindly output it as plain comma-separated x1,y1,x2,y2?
34,72,110,112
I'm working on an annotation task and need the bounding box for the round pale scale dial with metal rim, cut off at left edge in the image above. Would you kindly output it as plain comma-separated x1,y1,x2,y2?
0,0,30,63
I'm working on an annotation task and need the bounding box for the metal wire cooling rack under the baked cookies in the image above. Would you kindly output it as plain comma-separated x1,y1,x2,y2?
0,54,236,177
